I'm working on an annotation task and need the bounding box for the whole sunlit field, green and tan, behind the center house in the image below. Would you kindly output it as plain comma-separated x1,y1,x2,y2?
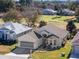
38,15,79,29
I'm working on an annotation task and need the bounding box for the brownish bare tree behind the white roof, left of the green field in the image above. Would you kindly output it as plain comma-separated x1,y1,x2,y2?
22,7,39,26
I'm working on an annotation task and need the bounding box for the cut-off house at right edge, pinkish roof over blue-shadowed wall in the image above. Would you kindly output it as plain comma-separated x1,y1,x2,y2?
72,32,79,55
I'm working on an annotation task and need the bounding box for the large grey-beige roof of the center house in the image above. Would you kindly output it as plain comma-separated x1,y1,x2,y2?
38,23,68,38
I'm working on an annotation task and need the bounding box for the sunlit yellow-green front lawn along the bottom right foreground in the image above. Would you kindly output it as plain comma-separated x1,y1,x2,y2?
32,41,71,59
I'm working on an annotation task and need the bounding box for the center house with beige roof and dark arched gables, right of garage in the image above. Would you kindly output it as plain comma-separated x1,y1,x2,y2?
38,24,69,48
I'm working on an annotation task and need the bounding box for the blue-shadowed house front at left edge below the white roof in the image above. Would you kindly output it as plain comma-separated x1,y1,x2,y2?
0,28,16,44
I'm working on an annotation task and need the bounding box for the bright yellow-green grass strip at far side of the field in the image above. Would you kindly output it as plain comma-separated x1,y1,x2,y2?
39,15,74,22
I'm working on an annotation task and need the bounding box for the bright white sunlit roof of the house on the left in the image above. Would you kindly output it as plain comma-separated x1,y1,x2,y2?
3,22,32,34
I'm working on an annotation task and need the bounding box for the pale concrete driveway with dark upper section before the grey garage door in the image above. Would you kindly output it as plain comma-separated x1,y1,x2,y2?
3,48,30,59
